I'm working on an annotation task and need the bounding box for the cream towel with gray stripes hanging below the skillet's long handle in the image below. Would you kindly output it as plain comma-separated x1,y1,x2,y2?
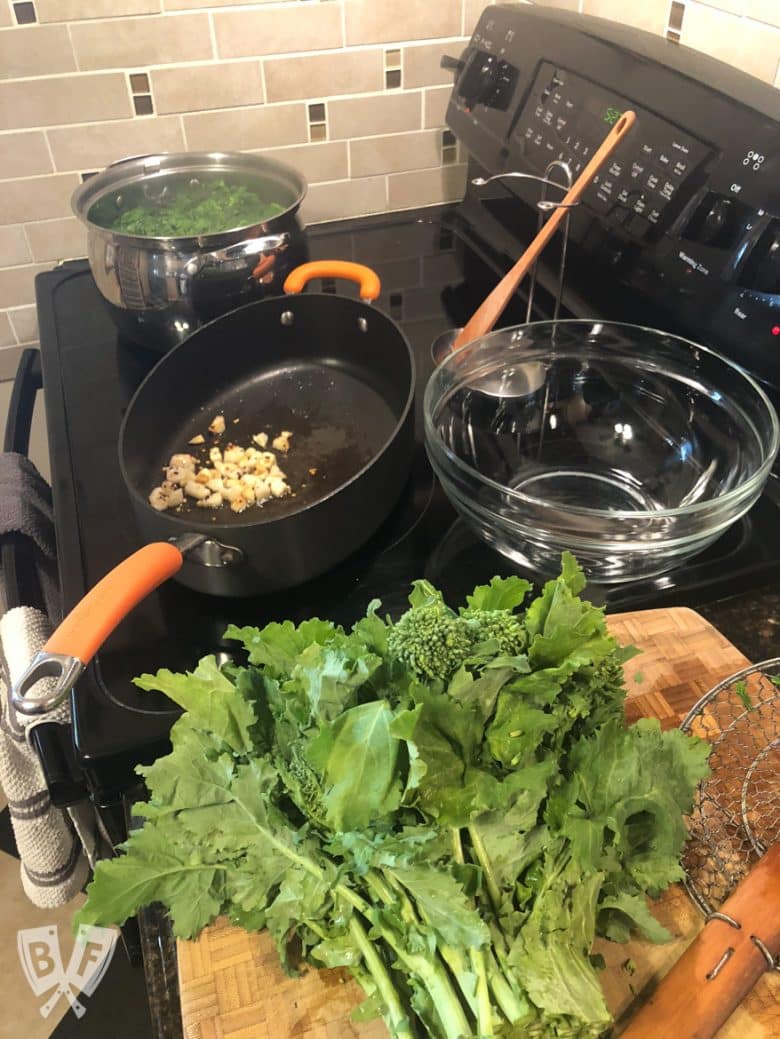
0,607,96,909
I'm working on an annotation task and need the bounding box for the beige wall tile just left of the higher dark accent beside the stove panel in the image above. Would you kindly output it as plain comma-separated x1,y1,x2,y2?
263,50,384,101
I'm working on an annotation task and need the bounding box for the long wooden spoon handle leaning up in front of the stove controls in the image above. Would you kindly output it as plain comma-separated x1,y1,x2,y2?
452,111,637,350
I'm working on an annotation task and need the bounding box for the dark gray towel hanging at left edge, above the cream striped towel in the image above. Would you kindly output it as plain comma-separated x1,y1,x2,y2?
0,451,61,620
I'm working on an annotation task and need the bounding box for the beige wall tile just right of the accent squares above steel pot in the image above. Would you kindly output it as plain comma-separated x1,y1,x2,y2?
152,61,263,114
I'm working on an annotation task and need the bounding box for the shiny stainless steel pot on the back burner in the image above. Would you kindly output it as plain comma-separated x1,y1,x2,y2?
72,152,308,352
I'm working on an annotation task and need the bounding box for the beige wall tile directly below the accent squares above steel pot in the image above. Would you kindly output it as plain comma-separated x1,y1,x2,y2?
49,115,184,169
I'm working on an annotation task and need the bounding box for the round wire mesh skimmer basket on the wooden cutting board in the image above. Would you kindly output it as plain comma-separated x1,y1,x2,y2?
680,658,780,964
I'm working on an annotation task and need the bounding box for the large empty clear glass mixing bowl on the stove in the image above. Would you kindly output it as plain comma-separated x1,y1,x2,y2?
424,321,780,582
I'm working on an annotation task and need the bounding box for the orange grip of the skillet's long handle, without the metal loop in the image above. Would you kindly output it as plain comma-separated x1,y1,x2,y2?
44,541,184,664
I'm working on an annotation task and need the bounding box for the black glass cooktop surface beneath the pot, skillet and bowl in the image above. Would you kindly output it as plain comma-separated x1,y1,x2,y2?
36,207,780,791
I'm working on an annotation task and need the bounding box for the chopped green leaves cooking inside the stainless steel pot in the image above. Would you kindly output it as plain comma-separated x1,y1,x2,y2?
111,180,285,238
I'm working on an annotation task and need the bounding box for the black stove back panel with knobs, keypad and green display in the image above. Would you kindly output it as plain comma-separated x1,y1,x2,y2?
447,4,780,398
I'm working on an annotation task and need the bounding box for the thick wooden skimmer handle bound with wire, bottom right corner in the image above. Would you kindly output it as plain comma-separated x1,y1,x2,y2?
621,844,780,1039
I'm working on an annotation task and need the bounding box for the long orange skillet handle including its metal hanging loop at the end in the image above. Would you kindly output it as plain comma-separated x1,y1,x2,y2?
11,541,184,715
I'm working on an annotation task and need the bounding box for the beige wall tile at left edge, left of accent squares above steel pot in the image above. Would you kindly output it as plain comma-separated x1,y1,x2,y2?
0,73,132,130
